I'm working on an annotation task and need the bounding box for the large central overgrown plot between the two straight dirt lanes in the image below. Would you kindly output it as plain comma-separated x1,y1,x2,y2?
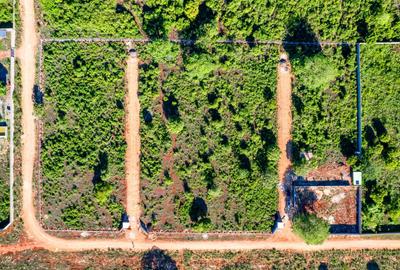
139,42,279,232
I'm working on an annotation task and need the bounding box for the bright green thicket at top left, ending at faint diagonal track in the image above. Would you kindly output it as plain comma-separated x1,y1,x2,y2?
37,0,140,38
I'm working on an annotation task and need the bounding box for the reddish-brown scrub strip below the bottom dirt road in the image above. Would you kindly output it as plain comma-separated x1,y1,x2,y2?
0,249,400,270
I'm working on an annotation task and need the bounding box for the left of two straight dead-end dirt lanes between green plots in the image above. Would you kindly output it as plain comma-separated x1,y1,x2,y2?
125,53,141,232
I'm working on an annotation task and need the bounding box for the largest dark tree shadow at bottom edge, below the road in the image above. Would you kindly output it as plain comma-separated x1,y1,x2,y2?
141,247,178,270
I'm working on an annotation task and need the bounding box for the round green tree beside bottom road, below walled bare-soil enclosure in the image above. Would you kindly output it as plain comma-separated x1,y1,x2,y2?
293,214,329,245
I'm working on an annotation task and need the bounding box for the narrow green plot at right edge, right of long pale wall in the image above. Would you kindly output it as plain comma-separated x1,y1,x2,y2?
361,44,400,231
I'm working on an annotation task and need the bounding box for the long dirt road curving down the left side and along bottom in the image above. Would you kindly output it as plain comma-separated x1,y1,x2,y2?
7,0,400,253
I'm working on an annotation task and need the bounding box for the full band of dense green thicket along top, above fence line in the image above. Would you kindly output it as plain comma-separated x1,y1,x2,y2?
40,0,400,41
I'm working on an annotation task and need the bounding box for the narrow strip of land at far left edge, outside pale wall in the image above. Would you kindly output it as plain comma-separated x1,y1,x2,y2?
0,33,10,229
